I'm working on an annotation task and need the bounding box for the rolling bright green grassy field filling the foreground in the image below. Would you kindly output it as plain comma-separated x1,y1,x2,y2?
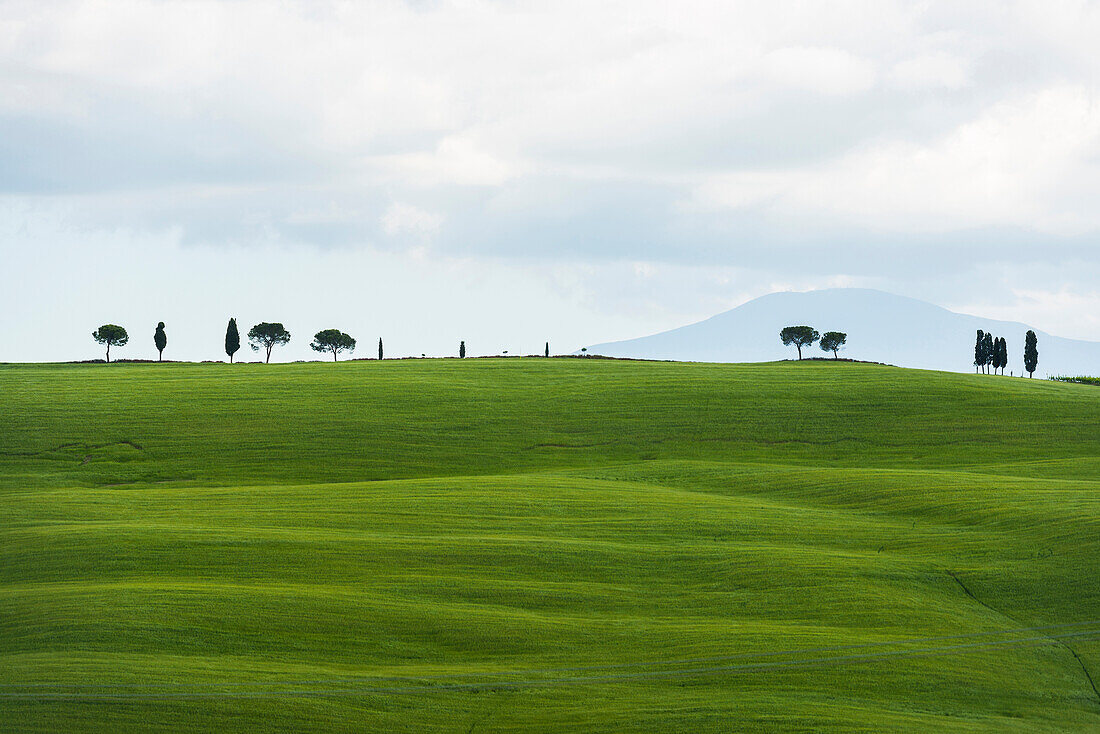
0,359,1100,732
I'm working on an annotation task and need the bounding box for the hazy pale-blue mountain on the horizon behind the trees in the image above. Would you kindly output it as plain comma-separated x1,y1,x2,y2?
587,288,1100,377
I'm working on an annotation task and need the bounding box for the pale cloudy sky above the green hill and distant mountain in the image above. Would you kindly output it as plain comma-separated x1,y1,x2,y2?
0,0,1100,361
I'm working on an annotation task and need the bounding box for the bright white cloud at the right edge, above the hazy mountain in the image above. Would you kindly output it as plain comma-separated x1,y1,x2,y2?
694,86,1100,235
